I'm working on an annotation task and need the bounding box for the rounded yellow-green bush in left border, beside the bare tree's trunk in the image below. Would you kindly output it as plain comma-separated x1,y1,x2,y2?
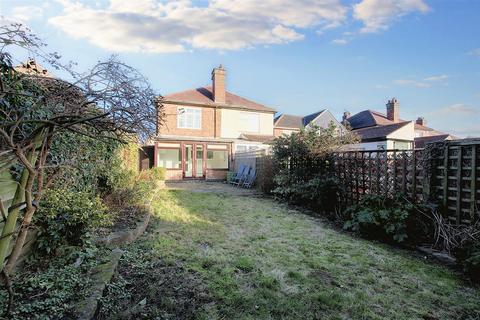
35,189,110,254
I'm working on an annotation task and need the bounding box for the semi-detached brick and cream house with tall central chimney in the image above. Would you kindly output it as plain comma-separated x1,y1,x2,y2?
150,65,275,180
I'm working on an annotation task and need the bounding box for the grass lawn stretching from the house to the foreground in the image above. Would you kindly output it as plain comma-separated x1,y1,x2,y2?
99,190,480,319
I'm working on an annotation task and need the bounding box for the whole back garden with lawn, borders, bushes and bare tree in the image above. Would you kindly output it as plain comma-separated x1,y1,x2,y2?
0,24,480,319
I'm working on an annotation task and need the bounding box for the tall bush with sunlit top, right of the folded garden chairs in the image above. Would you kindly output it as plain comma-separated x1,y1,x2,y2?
273,123,356,214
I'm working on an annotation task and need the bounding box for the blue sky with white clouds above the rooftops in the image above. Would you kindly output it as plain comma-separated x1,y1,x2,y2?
0,0,480,137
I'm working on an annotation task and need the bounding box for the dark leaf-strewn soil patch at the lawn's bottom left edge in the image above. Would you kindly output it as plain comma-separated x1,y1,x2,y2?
96,259,212,320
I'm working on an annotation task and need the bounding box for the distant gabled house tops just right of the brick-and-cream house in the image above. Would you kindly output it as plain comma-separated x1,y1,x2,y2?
273,109,343,137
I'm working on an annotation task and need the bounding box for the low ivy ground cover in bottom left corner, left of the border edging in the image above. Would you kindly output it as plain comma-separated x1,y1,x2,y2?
0,246,104,320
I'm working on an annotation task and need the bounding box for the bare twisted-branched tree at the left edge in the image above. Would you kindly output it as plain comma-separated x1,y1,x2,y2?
0,24,161,314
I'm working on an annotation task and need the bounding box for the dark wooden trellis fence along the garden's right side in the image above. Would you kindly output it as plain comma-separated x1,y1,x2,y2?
334,140,480,224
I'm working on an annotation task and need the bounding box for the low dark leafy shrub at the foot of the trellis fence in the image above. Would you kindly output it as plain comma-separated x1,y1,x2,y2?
344,194,426,242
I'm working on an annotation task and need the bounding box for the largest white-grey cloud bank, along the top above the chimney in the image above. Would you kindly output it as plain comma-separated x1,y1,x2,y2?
49,0,347,53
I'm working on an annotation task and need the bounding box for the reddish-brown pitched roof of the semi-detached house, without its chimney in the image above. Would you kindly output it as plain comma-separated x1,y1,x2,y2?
163,86,275,112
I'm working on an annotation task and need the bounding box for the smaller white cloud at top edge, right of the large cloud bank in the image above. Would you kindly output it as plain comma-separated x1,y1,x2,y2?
353,0,430,33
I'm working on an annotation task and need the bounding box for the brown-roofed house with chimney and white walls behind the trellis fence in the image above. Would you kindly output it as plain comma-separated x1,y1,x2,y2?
342,98,456,150
